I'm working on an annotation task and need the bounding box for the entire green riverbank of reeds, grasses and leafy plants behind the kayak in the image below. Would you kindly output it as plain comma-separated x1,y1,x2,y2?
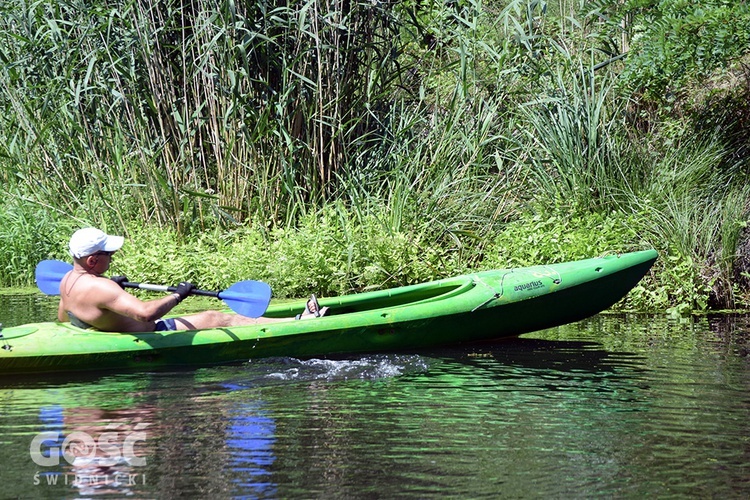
0,0,750,311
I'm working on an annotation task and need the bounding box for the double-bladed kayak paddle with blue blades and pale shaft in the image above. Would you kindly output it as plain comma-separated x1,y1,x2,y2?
36,260,271,318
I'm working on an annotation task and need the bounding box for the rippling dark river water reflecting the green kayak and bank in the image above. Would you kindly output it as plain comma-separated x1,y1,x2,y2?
0,295,750,498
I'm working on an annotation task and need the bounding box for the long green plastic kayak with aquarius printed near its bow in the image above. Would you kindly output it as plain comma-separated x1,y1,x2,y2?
0,250,657,373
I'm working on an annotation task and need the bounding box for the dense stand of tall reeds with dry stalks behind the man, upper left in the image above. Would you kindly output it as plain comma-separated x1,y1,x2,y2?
0,0,412,232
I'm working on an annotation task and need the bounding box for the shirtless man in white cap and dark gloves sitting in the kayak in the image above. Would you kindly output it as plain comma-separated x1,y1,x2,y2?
57,227,328,332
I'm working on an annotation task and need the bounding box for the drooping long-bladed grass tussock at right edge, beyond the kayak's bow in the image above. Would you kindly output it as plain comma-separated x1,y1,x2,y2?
631,137,750,309
